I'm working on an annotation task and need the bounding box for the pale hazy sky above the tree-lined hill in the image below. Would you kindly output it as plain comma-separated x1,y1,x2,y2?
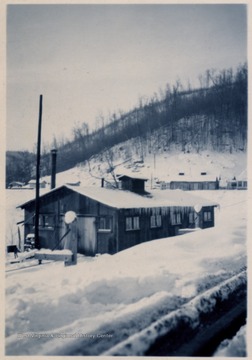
6,4,247,150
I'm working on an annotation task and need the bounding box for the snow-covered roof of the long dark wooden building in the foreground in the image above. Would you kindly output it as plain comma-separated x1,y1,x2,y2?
19,185,218,209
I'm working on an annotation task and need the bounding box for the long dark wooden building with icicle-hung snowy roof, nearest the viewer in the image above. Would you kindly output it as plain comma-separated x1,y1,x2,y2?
19,186,218,256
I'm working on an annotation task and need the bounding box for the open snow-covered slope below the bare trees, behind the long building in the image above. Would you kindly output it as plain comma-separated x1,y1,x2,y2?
43,149,247,188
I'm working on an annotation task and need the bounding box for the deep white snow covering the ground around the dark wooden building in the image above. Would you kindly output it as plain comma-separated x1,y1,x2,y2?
6,190,250,356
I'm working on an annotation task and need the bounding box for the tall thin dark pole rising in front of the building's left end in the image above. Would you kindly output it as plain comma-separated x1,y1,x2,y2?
35,95,43,249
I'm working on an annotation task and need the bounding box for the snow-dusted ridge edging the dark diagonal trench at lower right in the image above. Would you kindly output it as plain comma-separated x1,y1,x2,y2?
101,271,247,356
